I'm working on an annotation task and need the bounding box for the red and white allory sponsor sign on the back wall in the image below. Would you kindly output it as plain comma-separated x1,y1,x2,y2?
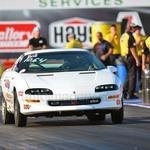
0,21,39,52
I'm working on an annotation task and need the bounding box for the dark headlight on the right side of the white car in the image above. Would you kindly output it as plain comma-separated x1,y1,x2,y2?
95,84,118,92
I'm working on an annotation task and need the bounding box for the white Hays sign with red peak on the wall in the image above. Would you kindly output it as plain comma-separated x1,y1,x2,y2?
49,17,94,48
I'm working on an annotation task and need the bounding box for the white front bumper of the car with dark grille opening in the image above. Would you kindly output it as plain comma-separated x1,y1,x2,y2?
19,91,123,115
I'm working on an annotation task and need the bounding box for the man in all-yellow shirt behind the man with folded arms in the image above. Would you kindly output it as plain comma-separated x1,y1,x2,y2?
105,24,120,65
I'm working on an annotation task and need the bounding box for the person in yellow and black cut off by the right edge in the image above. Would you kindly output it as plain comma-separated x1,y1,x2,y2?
142,35,150,71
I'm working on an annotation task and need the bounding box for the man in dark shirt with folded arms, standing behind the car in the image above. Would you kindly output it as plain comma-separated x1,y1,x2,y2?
93,32,113,66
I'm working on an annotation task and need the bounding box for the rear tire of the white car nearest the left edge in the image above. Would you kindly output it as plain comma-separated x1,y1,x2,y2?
1,95,15,124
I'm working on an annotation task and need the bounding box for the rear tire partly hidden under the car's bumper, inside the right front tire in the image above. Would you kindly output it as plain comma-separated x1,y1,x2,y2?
86,113,105,122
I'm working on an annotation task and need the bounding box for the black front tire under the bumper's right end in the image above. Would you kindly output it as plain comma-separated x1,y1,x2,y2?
111,107,124,124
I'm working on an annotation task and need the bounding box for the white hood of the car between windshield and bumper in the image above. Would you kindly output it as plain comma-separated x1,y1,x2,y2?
22,69,116,93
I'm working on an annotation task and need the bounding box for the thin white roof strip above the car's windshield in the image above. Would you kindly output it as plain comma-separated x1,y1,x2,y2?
24,48,88,55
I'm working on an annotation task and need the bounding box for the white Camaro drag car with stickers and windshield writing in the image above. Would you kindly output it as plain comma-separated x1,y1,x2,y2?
1,49,123,127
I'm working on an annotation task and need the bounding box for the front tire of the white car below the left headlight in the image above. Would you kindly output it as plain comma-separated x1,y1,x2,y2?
14,92,27,127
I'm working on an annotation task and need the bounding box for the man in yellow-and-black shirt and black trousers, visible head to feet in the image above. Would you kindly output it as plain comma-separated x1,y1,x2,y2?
120,25,140,99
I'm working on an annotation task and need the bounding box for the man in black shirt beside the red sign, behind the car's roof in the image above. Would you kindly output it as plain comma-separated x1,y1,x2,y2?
29,27,47,50
